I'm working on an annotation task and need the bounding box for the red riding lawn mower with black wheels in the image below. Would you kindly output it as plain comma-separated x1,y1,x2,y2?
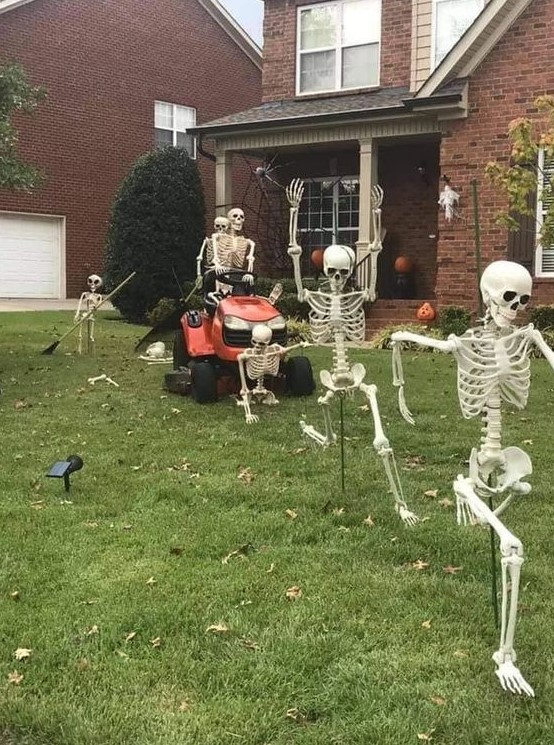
165,270,315,404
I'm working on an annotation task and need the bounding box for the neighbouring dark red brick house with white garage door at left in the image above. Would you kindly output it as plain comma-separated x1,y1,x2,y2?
0,0,261,298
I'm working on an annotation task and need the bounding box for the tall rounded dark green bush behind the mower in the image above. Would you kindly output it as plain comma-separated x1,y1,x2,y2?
105,147,205,321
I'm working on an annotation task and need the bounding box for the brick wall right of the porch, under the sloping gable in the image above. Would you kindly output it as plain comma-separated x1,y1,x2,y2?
437,0,554,308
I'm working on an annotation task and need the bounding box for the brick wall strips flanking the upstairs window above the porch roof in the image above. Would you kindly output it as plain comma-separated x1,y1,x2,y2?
263,0,412,101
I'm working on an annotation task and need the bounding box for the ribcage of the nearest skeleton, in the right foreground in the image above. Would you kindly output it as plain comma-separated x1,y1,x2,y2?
454,329,530,419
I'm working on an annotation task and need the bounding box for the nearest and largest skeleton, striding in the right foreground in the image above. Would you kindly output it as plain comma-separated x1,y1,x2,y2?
392,261,554,696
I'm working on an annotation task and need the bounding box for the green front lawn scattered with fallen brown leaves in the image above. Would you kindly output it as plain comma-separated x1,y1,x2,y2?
0,312,554,745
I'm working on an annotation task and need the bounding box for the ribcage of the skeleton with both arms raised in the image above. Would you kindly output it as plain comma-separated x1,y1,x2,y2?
306,291,365,344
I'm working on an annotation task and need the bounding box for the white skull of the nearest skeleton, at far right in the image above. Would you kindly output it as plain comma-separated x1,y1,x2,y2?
480,261,533,328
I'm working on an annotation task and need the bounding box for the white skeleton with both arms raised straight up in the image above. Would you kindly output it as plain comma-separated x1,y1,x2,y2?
286,179,418,525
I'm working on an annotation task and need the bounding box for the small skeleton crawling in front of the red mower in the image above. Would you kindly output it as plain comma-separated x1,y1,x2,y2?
237,323,311,424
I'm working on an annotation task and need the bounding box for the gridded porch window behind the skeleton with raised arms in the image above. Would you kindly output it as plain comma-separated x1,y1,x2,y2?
298,177,360,248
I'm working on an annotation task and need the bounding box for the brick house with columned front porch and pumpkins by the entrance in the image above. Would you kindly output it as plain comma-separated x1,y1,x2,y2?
190,0,554,328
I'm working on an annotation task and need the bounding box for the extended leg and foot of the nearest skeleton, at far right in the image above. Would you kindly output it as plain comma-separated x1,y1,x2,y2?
454,476,535,696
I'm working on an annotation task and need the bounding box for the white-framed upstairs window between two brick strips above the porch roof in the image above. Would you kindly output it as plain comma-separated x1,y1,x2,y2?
296,0,381,93
